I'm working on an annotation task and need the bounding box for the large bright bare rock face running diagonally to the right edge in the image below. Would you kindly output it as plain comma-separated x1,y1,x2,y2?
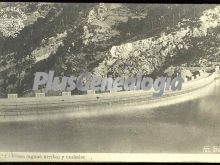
95,6,220,75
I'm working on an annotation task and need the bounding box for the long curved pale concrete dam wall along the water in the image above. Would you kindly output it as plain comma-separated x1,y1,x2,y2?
0,73,216,121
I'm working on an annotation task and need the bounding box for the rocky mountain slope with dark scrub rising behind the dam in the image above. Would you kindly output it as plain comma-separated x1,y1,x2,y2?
0,3,220,97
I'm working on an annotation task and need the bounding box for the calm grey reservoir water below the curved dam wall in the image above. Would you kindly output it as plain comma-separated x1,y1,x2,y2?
0,80,220,153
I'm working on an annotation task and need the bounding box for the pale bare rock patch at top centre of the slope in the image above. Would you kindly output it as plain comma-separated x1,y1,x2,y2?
83,3,147,45
